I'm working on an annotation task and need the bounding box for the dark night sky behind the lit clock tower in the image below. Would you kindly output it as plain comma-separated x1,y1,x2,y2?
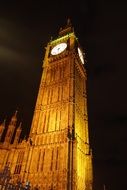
0,0,127,190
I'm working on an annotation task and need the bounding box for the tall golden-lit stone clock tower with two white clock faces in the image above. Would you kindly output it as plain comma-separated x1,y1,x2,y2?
24,20,92,190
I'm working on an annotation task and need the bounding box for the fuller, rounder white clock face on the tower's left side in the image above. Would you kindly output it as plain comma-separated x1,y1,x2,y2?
51,43,67,55
